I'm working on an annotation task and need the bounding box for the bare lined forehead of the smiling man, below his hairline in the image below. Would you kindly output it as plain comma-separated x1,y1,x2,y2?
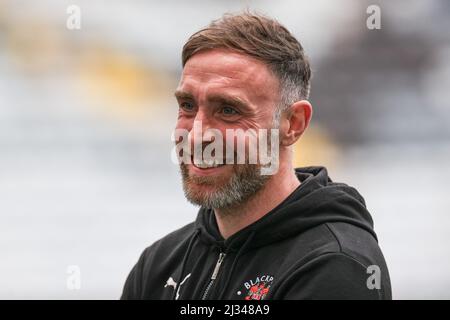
178,49,278,99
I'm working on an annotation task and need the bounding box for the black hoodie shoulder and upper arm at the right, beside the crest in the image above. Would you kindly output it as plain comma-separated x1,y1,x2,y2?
274,222,391,299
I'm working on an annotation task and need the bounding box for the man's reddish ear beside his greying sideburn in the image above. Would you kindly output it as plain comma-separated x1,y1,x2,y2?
280,100,313,146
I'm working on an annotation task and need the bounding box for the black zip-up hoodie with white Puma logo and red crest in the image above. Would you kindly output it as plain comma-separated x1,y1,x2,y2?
122,167,391,300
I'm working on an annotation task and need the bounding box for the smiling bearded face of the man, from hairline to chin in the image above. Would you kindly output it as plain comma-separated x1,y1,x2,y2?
175,49,279,208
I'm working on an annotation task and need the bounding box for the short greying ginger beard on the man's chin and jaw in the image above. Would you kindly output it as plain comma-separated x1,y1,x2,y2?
180,163,269,210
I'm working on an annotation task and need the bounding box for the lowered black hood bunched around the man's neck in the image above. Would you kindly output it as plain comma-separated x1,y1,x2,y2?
195,166,377,253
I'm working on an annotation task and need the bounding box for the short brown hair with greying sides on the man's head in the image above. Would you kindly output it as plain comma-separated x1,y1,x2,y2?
182,12,311,120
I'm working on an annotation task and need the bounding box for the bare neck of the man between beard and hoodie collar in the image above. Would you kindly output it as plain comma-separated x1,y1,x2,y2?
214,159,300,239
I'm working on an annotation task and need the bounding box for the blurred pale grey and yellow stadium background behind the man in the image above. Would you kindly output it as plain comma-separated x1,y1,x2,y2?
0,0,450,299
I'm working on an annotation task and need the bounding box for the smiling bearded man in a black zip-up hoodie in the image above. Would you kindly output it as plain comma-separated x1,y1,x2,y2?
122,13,391,300
